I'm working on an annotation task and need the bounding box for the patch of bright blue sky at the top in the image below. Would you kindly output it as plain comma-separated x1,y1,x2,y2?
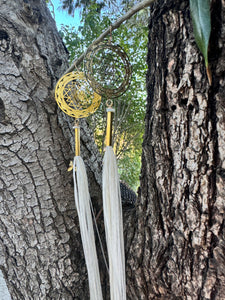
48,0,80,30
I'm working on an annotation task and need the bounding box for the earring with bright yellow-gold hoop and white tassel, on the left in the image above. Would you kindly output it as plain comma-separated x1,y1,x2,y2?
55,72,103,300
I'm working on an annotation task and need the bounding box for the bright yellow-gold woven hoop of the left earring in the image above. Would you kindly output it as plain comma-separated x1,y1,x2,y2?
55,72,101,119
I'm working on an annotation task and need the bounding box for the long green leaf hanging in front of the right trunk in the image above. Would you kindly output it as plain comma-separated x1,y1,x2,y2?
189,0,211,67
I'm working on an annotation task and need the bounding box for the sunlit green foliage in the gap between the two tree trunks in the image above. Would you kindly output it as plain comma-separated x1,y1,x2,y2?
60,3,148,189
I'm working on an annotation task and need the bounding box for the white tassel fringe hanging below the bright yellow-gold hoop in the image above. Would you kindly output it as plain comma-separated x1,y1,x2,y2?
73,156,103,300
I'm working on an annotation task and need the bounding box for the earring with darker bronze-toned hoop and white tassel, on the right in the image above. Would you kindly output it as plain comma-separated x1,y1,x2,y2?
84,43,131,300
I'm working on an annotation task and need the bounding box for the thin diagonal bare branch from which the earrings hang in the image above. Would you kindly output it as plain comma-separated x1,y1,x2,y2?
62,0,155,74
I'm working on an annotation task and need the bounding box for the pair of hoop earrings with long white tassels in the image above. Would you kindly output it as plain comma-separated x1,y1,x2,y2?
55,44,131,300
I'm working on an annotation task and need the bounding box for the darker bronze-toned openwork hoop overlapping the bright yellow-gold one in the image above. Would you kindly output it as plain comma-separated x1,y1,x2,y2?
84,43,131,98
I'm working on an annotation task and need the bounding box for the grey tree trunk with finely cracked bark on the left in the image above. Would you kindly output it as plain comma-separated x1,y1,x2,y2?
0,0,101,300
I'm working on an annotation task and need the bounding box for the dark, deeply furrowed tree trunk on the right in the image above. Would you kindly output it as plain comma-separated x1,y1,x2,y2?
127,0,225,300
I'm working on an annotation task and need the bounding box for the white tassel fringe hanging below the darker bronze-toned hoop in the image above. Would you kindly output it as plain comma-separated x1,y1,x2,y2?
102,146,126,300
